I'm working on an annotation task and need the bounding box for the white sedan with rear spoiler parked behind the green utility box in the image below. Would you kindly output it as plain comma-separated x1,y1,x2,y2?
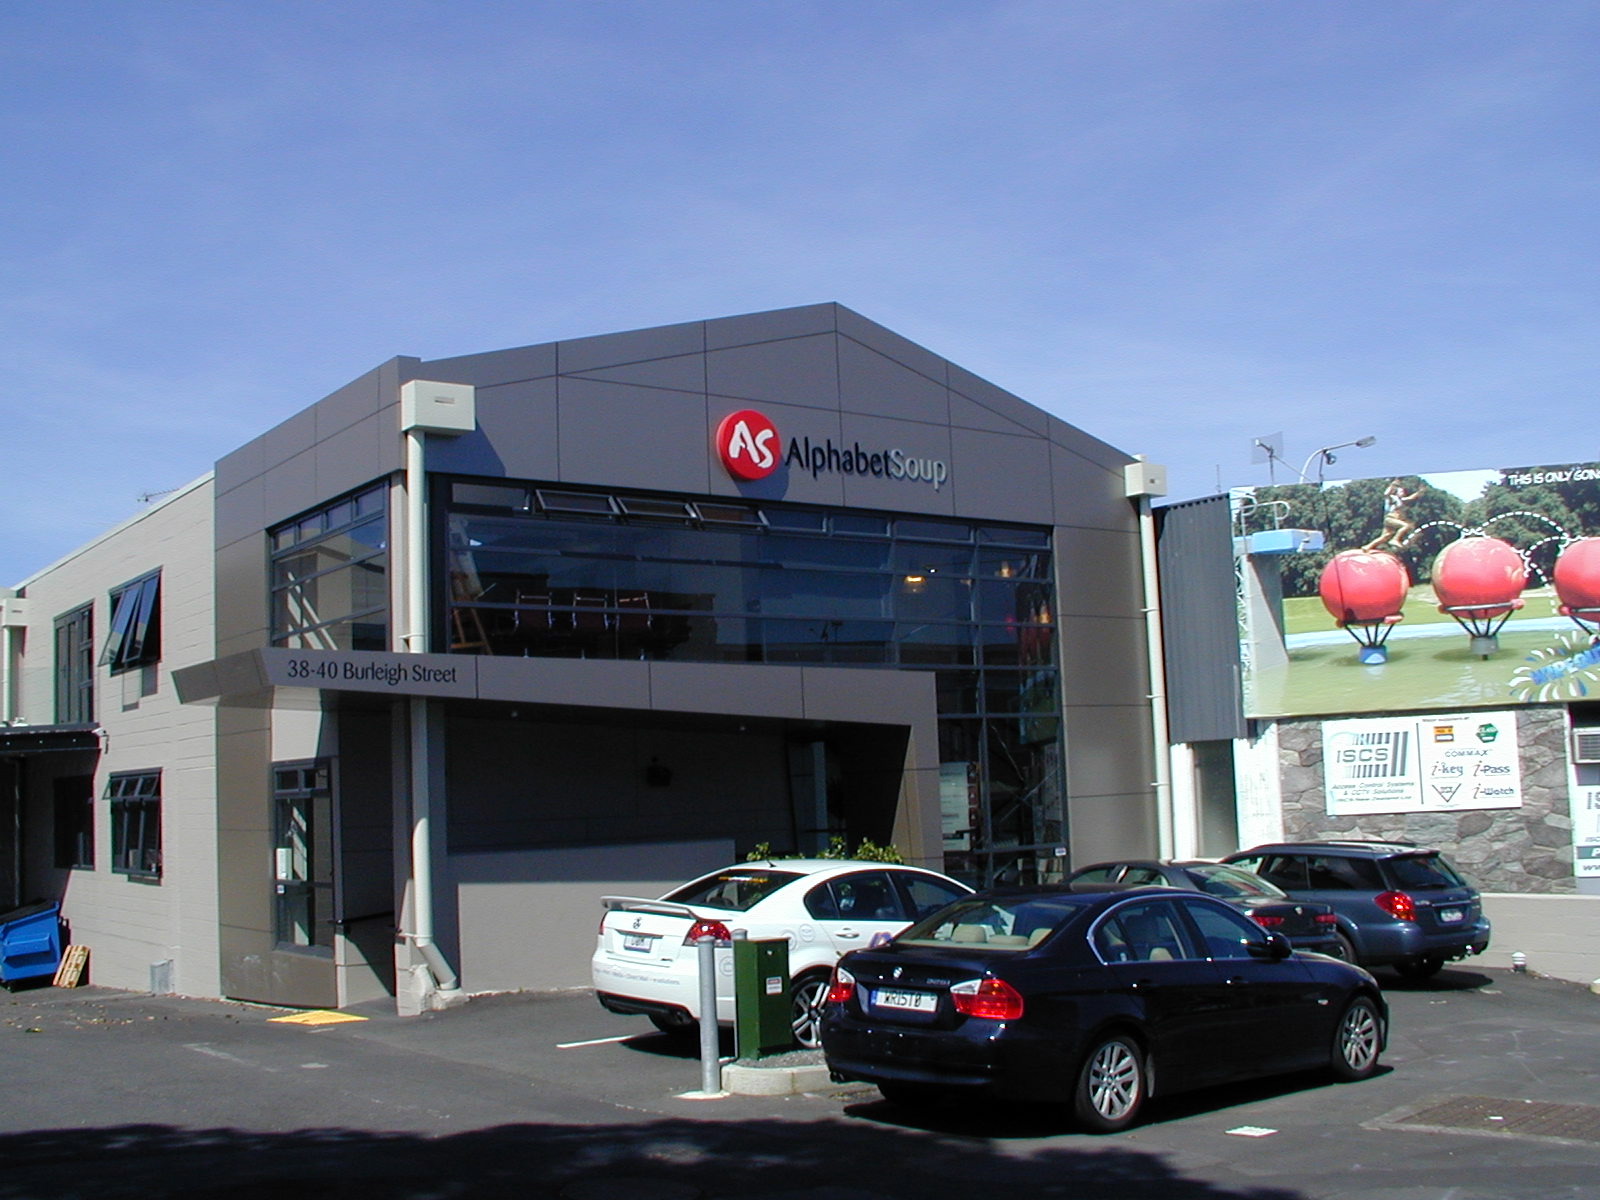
592,859,971,1046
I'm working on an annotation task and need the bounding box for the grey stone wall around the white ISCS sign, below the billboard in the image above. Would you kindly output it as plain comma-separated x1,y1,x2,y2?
1278,706,1576,893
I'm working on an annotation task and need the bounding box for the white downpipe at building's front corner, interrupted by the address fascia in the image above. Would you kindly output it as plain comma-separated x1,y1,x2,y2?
405,429,461,992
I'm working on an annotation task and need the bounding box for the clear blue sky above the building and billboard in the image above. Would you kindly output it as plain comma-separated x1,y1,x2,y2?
0,0,1600,582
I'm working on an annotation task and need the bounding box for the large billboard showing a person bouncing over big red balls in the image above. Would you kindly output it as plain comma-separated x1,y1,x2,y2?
1232,462,1600,717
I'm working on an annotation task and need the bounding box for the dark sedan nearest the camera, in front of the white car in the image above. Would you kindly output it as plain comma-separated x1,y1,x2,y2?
822,888,1389,1133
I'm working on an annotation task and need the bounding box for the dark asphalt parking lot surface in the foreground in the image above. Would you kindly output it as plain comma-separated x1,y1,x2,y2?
0,966,1600,1200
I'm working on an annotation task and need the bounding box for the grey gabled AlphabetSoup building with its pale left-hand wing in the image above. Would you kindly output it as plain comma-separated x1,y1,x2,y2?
0,304,1165,1011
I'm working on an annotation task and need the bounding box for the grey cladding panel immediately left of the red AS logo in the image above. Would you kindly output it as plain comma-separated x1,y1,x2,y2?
560,376,722,493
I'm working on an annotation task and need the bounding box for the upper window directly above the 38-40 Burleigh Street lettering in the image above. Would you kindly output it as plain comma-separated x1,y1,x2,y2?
267,485,389,650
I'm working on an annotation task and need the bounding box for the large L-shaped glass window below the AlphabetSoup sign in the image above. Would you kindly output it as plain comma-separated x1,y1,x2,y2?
435,480,1066,882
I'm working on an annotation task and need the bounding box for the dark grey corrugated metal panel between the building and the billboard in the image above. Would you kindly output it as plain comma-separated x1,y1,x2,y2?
1155,496,1245,742
